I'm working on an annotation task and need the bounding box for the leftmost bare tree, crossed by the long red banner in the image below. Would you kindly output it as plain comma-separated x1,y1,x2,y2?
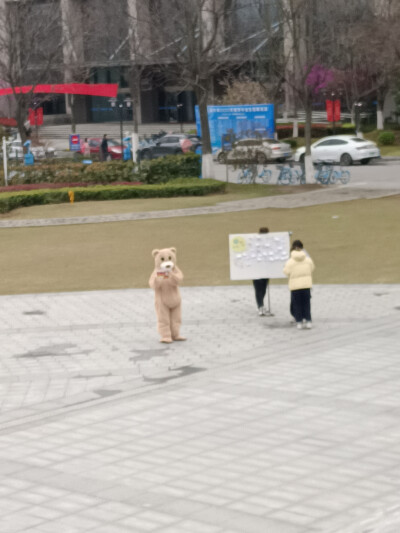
0,0,62,140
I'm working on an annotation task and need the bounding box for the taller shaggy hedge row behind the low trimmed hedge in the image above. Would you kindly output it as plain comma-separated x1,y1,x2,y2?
0,154,200,185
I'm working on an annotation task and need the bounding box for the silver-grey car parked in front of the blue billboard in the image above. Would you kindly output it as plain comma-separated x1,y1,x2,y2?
216,139,292,164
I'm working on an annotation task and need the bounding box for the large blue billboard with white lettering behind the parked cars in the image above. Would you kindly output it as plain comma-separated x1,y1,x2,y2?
195,104,275,153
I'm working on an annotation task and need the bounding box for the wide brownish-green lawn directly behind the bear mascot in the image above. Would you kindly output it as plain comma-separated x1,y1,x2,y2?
0,197,400,294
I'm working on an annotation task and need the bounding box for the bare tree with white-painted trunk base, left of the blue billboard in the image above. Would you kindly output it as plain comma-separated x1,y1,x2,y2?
151,0,248,178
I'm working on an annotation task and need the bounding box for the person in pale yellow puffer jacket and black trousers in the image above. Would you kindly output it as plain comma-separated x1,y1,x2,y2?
283,240,315,329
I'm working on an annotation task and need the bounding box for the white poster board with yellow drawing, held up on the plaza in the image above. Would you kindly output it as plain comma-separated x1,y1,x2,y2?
229,232,290,280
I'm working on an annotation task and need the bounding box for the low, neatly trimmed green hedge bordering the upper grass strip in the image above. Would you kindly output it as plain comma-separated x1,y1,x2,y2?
0,179,226,213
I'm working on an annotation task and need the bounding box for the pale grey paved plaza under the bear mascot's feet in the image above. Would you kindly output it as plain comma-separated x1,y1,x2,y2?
0,285,400,533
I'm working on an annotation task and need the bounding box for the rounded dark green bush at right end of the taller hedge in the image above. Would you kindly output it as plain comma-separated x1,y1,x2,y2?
140,153,201,184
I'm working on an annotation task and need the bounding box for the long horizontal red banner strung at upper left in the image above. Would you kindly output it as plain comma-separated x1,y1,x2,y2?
0,83,118,98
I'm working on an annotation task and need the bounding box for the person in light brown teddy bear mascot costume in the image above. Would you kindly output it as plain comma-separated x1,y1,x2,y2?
149,248,186,343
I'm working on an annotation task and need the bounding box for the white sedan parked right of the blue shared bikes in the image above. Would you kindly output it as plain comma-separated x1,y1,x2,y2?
294,135,381,165
